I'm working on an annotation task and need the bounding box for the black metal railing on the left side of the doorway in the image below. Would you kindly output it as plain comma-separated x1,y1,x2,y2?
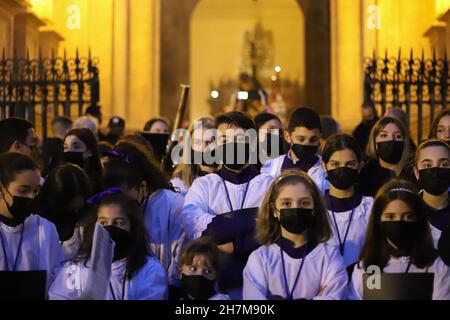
0,49,100,139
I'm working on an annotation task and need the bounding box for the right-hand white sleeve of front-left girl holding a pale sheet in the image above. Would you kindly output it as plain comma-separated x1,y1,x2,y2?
133,258,168,300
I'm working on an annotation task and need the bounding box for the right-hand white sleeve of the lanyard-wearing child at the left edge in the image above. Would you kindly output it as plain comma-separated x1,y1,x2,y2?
38,218,64,289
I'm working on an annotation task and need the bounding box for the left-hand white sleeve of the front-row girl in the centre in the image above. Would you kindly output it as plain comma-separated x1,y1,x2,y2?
243,251,268,300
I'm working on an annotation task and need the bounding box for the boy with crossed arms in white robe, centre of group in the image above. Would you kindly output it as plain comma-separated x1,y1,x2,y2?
182,112,273,300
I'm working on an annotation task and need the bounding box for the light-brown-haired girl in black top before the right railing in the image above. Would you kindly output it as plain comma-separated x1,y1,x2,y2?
359,117,412,197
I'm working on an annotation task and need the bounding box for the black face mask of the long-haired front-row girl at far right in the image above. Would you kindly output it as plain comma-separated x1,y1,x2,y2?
381,221,417,252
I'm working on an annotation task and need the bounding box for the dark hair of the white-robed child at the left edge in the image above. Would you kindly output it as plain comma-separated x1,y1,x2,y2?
0,152,38,187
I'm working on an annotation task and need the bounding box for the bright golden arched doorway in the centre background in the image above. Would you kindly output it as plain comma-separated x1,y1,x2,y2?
189,0,306,119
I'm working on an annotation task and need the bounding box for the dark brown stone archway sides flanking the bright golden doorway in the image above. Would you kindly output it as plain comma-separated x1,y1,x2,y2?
160,0,331,119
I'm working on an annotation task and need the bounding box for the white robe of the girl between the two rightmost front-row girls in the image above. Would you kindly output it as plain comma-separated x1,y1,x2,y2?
328,197,373,267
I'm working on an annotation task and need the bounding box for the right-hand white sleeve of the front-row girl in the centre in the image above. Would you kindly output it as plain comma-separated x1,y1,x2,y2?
313,248,348,300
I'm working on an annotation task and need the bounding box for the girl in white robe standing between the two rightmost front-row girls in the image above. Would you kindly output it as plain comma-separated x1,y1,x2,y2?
322,134,373,271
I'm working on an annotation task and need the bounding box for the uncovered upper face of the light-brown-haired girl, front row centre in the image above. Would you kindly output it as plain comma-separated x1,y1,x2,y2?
274,183,314,219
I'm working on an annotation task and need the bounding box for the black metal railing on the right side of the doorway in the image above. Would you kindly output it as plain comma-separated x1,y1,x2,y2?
364,50,450,142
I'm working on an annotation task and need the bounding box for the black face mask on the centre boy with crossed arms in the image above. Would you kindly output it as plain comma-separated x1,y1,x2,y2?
217,142,250,170
